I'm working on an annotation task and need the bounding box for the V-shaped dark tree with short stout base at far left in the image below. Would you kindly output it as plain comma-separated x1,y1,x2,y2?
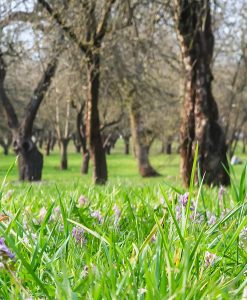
0,50,57,181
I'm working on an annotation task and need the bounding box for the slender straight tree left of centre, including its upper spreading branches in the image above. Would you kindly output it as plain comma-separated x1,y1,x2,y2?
38,0,120,184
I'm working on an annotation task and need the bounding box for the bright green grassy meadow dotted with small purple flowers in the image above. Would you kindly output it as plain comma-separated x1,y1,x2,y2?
0,142,247,299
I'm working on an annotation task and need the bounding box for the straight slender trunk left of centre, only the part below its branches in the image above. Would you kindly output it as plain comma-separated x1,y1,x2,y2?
86,49,107,184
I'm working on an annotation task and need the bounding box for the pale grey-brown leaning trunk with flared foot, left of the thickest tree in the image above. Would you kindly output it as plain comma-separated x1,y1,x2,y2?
130,99,159,177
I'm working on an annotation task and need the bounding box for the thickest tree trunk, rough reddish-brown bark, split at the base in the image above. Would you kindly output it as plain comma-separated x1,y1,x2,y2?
174,0,229,186
